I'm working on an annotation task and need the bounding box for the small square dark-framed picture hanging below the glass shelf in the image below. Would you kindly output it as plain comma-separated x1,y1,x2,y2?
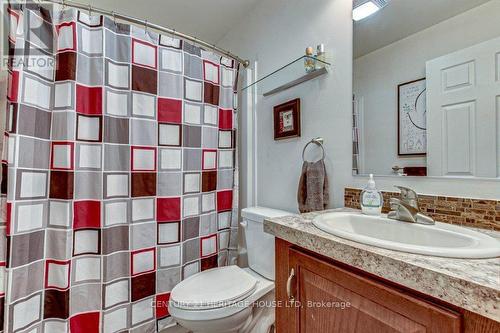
274,98,300,140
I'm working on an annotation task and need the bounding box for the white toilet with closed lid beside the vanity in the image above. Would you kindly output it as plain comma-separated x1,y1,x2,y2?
169,207,292,333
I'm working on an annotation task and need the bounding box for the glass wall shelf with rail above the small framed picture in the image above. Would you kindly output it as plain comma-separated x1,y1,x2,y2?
242,56,330,96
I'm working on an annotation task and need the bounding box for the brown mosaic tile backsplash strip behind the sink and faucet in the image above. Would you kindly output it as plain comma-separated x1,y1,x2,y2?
344,188,500,231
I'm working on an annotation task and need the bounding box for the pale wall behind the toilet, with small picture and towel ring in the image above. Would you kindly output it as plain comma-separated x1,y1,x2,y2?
218,0,352,211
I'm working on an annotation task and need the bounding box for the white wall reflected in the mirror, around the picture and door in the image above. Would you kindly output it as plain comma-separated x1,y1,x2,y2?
353,1,500,175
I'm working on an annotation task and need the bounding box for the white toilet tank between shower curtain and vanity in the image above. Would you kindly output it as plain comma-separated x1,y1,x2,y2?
241,207,293,281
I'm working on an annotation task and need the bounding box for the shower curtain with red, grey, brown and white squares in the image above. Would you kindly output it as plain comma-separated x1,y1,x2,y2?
0,3,239,333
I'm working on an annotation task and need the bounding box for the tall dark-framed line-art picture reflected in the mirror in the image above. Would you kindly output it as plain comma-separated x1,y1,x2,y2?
398,78,427,156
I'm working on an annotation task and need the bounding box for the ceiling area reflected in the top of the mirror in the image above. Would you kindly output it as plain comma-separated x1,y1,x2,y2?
354,0,497,58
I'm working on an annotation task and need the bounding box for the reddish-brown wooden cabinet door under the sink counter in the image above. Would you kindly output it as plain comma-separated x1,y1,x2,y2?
289,249,461,333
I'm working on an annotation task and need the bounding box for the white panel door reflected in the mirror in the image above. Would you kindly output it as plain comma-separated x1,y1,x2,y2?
426,38,500,178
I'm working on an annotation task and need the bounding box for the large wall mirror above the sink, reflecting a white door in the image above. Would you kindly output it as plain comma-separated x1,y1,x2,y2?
353,0,500,180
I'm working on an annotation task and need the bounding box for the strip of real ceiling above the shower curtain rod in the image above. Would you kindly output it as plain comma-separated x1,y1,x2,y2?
86,0,261,44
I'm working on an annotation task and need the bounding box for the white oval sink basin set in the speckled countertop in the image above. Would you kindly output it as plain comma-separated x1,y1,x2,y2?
313,212,500,258
